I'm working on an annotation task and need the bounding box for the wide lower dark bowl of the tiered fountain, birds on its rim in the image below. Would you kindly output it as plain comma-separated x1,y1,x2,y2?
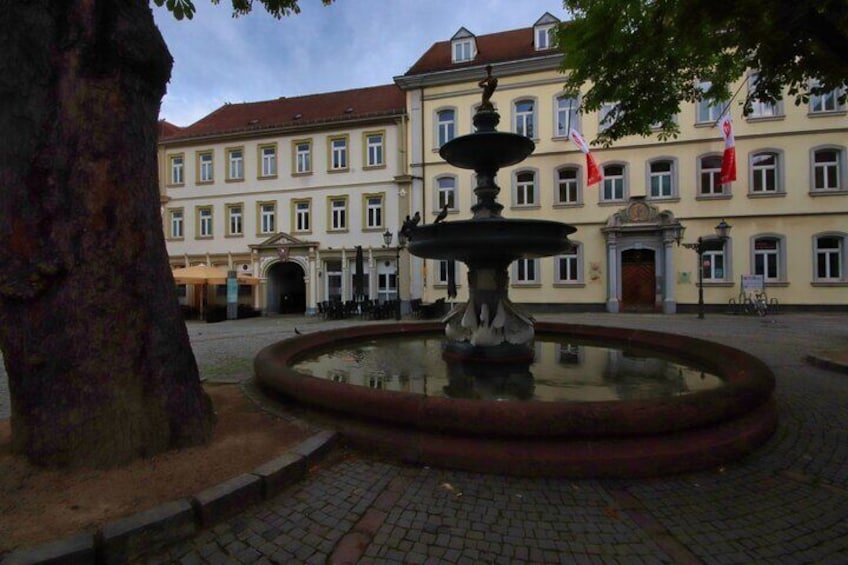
407,218,576,265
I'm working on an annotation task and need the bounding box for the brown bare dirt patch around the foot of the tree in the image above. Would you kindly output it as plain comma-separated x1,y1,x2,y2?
0,384,312,556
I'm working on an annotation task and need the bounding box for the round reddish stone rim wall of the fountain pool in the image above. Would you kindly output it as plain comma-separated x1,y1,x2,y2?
254,323,777,477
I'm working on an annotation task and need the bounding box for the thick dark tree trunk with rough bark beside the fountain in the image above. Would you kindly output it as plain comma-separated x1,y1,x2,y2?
0,0,214,467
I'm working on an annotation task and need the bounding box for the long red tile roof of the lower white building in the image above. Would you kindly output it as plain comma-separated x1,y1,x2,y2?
163,84,406,141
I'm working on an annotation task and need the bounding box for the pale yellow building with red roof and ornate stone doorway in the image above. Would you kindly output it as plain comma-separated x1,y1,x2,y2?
395,14,848,313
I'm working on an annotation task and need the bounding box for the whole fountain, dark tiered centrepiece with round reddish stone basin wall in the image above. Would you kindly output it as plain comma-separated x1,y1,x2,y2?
254,68,777,477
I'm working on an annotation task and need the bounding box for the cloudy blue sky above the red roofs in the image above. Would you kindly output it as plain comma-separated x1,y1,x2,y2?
153,0,568,126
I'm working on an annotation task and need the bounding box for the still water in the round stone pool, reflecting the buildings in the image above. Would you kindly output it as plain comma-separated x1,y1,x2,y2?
295,335,722,402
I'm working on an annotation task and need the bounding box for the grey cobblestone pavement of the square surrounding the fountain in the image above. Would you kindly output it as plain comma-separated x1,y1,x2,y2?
0,314,848,564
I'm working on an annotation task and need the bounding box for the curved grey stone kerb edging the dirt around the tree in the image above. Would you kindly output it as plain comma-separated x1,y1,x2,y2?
0,431,339,565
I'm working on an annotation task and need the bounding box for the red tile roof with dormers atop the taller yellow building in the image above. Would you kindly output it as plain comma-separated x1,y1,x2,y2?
404,27,556,76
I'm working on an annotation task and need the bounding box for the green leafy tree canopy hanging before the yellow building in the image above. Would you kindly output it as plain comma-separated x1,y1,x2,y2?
557,0,848,145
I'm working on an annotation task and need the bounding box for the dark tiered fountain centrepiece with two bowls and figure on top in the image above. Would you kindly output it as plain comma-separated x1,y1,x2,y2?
408,65,576,360
